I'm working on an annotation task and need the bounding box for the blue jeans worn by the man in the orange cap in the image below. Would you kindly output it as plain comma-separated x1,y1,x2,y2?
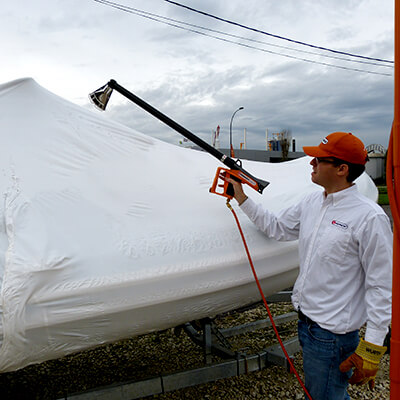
298,321,359,400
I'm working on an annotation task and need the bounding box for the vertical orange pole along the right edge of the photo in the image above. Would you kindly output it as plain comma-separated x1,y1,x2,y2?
387,0,400,400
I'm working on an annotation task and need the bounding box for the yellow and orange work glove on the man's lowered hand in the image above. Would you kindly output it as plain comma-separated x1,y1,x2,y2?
339,339,386,390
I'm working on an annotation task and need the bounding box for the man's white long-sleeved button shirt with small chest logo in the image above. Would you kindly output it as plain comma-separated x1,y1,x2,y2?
240,185,393,345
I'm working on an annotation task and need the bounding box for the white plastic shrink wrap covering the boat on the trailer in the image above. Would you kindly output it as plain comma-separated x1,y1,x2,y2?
0,78,377,372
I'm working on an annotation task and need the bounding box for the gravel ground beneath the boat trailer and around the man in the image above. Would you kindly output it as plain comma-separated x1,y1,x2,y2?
0,303,389,400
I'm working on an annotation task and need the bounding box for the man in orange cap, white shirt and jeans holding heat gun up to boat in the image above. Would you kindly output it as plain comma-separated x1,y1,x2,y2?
228,132,393,400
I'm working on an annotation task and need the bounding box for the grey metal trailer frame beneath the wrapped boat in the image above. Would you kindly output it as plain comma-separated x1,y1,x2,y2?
59,291,300,400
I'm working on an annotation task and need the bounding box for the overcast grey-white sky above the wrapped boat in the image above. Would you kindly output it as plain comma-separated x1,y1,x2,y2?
0,0,394,149
